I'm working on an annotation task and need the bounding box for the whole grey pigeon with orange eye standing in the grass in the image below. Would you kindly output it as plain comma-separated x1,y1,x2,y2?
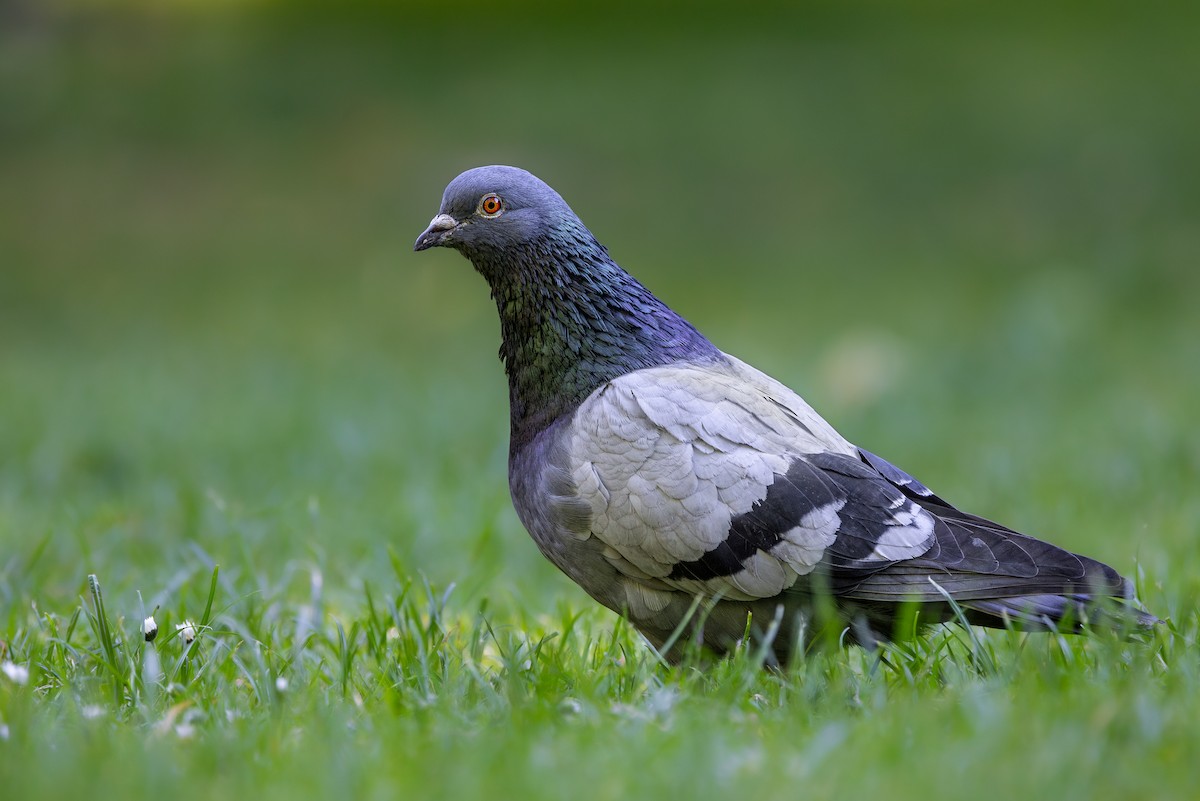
414,165,1154,664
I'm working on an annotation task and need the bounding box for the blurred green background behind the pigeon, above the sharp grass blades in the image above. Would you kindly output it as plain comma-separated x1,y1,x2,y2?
0,0,1200,615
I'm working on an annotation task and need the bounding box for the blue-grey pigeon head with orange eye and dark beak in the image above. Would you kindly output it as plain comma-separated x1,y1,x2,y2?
413,165,578,261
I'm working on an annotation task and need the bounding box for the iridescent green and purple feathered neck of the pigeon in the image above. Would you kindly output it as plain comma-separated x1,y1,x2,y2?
475,229,722,453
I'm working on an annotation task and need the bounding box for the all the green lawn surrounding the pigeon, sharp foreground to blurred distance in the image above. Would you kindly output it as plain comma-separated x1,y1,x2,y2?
0,4,1200,800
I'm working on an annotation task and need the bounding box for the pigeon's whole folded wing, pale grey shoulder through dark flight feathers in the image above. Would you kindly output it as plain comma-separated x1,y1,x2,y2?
568,360,1128,615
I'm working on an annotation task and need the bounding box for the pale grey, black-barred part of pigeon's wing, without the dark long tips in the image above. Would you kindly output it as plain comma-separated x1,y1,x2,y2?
568,360,936,600
